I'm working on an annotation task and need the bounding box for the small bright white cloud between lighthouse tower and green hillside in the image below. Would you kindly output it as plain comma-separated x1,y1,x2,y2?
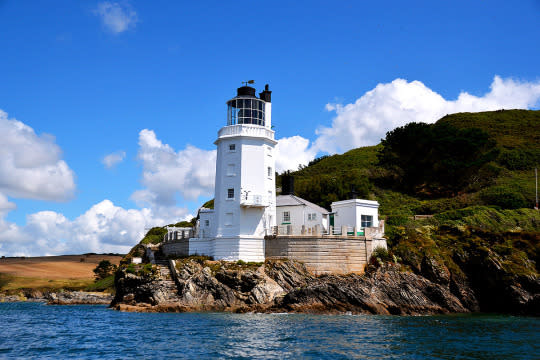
276,135,317,173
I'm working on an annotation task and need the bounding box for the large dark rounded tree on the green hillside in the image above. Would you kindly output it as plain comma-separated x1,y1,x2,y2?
377,123,498,195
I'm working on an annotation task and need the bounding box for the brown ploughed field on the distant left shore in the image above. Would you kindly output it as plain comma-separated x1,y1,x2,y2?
0,254,122,292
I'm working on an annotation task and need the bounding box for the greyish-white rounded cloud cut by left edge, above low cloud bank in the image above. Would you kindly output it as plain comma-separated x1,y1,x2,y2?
0,110,75,201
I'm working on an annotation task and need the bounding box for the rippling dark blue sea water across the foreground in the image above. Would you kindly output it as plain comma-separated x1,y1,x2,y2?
0,303,540,359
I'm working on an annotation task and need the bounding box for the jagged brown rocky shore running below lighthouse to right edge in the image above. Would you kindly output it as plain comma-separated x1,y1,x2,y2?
111,259,540,316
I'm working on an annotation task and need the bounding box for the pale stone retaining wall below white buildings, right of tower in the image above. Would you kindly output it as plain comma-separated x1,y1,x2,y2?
265,236,372,275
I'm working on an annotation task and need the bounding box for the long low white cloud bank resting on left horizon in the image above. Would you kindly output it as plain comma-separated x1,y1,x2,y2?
0,197,190,256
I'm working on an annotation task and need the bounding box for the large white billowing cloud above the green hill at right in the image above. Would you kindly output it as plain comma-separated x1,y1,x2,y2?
309,76,540,153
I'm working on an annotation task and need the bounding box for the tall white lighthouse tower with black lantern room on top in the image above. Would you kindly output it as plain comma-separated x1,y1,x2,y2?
210,85,277,261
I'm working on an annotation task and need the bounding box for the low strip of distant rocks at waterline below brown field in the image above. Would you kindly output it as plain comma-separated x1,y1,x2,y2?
0,290,113,305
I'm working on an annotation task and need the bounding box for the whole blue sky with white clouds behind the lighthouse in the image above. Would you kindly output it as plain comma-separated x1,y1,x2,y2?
0,0,540,256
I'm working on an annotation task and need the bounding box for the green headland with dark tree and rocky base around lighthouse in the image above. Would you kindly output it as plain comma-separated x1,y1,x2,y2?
115,110,540,315
